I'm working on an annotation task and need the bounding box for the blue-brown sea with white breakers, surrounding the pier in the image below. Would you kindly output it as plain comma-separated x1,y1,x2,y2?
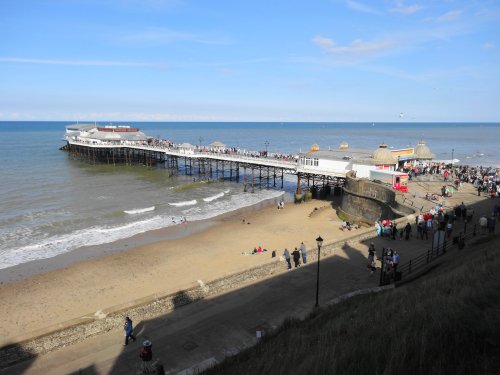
0,121,500,273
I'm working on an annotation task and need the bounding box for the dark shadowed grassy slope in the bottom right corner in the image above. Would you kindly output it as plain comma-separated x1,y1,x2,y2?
201,239,500,375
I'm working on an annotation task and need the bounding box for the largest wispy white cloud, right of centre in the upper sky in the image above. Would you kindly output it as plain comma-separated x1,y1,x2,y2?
312,36,397,55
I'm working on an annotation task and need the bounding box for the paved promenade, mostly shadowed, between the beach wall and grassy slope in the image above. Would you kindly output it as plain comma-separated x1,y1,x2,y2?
1,181,498,374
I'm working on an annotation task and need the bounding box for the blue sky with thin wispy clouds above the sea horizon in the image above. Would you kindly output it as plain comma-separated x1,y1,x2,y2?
0,0,500,122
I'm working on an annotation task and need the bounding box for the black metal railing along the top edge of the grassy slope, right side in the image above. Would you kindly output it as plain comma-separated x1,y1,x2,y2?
380,222,477,286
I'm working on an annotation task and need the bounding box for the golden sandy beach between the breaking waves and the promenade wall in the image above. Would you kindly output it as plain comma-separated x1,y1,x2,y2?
0,201,349,343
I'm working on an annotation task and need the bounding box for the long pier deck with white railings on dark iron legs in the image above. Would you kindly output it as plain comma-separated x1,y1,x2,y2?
61,137,345,192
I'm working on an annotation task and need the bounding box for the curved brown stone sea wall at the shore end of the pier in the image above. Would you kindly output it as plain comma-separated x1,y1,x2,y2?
340,173,414,223
